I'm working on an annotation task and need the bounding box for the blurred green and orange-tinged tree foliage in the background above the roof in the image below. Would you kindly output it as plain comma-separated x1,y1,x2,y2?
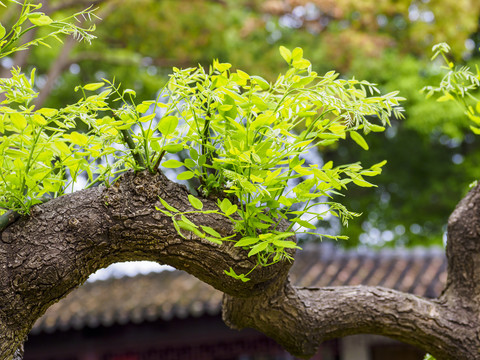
0,0,480,246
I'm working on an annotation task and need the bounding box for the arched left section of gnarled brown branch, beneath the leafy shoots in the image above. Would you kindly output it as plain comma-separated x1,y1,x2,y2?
0,172,290,359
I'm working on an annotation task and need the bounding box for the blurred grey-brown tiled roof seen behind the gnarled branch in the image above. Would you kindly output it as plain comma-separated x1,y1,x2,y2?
32,244,446,333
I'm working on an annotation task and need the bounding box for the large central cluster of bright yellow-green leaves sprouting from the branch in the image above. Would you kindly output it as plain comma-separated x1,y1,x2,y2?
152,47,402,280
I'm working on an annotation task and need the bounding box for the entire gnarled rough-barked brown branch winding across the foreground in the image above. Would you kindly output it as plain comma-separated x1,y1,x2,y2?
0,172,480,360
